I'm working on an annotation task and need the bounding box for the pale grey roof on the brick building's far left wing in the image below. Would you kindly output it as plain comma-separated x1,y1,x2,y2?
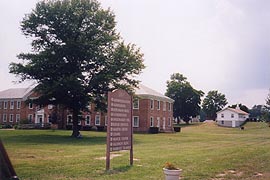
0,87,33,99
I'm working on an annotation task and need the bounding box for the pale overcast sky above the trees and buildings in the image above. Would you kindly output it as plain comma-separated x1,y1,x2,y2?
0,0,270,108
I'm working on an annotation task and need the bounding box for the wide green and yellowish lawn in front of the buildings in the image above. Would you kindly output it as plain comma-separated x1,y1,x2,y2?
0,123,270,180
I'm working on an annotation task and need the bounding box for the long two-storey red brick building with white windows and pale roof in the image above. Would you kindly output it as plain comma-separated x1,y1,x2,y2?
0,84,174,133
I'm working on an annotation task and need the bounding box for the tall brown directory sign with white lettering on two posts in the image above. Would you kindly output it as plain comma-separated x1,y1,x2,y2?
106,89,133,170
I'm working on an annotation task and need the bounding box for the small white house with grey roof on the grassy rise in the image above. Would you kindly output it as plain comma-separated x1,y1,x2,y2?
216,105,249,127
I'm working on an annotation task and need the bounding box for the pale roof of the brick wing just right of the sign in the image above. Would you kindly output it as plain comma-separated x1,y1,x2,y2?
135,84,174,102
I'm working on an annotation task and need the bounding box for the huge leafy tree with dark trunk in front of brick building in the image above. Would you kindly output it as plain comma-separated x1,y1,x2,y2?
10,0,144,137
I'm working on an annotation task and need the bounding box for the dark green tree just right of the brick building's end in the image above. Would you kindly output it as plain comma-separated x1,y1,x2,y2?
165,73,204,123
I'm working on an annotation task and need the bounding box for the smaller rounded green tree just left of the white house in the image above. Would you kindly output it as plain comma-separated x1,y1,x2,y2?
202,90,228,120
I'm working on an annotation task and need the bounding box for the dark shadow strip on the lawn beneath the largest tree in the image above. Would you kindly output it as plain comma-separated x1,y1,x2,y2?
2,133,106,145
